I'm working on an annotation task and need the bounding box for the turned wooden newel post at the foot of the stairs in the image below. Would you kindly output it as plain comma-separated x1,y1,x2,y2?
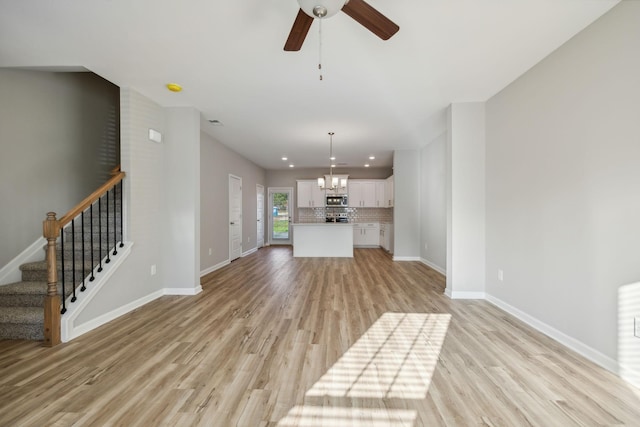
42,212,61,347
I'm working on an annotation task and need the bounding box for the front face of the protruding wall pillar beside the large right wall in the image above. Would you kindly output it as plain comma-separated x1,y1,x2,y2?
445,102,485,298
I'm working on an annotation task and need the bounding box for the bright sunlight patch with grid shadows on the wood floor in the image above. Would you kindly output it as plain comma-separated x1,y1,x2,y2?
278,313,451,426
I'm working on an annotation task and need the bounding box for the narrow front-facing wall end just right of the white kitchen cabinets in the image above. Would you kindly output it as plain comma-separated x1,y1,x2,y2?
393,150,420,261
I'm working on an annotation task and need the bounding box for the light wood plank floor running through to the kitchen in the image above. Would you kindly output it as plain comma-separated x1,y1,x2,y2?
0,247,640,427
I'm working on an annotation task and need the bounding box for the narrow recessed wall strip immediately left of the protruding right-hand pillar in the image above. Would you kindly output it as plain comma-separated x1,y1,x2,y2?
420,133,447,274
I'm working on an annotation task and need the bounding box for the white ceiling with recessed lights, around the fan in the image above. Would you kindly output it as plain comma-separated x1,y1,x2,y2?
0,0,618,169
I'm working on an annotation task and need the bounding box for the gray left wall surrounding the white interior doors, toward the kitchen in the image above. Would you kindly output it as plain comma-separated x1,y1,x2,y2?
200,132,267,271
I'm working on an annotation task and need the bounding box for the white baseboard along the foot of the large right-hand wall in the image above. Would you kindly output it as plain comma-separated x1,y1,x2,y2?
485,294,618,374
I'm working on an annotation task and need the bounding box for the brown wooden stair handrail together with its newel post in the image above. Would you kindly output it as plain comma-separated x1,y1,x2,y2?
42,165,126,347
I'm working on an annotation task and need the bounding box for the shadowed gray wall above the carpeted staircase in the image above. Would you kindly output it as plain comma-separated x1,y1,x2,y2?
0,69,120,267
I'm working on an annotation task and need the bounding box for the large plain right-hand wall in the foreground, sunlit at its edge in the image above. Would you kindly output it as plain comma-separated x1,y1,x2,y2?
486,2,640,372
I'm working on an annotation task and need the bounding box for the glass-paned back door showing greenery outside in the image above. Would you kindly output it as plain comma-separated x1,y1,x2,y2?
269,187,295,245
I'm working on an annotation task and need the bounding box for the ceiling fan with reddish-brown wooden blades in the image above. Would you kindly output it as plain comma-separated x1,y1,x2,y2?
284,0,400,51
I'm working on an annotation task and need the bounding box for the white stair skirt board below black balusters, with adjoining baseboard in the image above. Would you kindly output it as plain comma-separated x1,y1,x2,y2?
60,242,134,342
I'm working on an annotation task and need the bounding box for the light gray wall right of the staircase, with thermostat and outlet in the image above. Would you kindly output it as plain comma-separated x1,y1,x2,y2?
75,89,200,327
